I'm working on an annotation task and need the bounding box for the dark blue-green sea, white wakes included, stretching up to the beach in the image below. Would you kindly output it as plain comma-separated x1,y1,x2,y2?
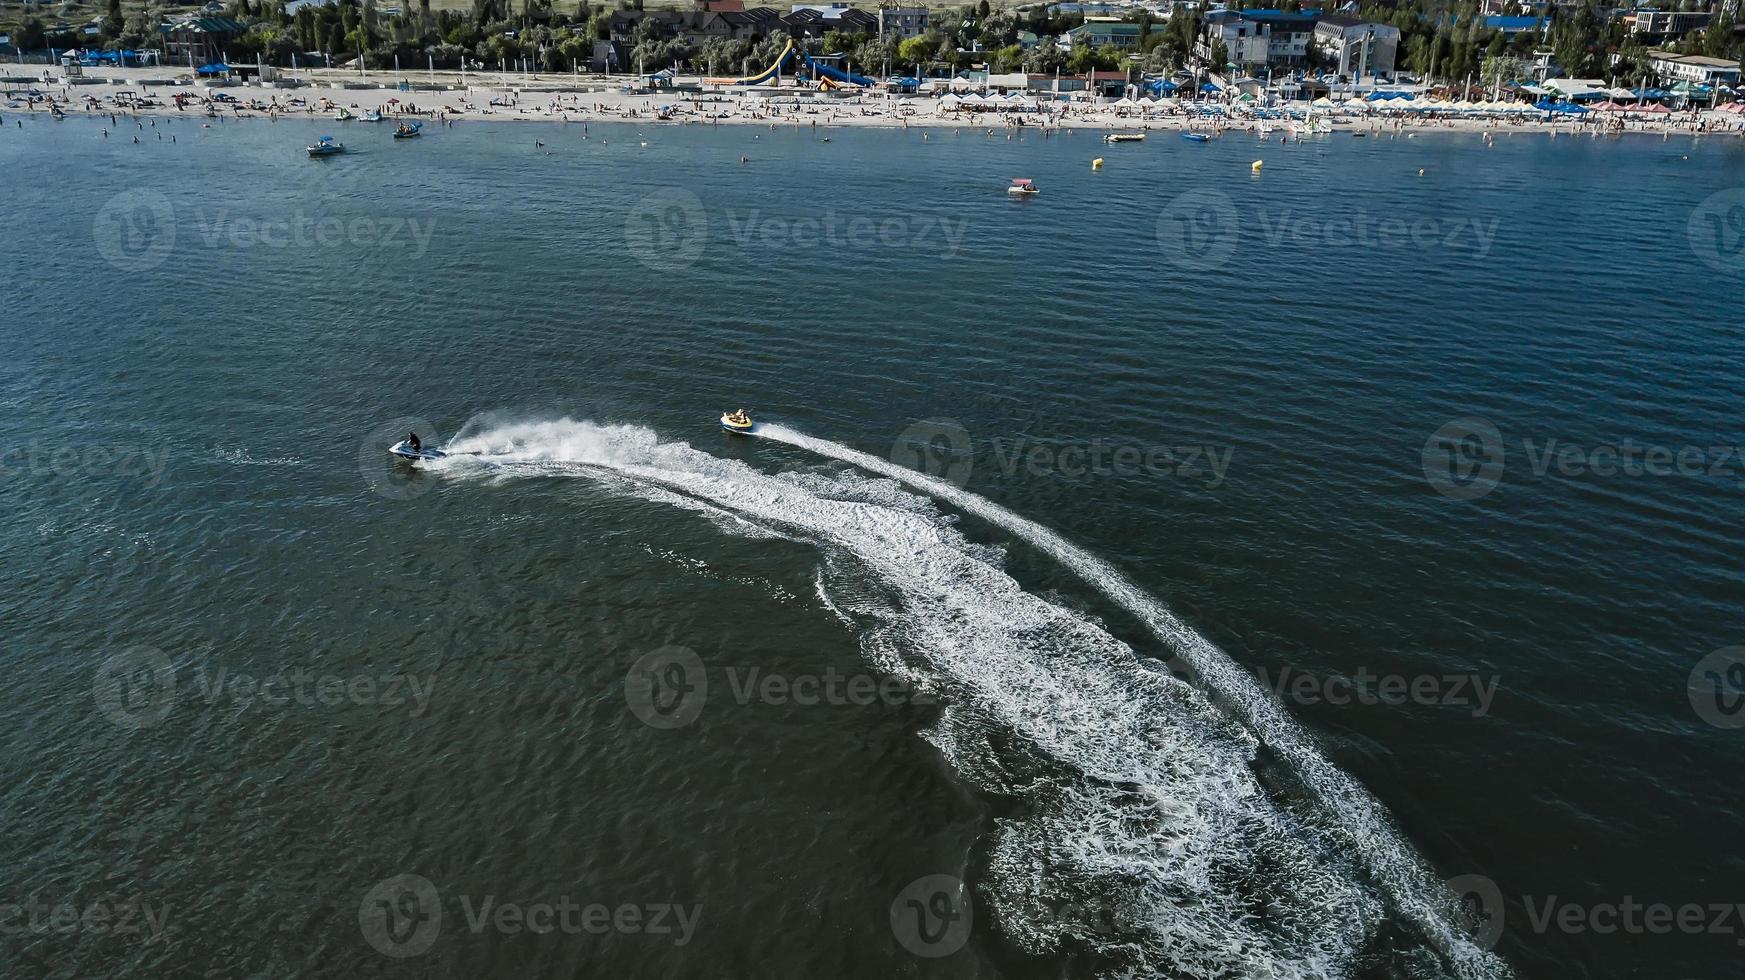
0,113,1745,980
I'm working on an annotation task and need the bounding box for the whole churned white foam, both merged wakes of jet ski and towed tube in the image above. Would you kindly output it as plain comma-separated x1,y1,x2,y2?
431,419,1508,980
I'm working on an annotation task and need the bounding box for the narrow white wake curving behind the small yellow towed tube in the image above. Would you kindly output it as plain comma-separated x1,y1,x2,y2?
757,424,1511,980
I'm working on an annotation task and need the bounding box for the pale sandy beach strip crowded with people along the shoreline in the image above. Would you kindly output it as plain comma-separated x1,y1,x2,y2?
13,66,1745,140
